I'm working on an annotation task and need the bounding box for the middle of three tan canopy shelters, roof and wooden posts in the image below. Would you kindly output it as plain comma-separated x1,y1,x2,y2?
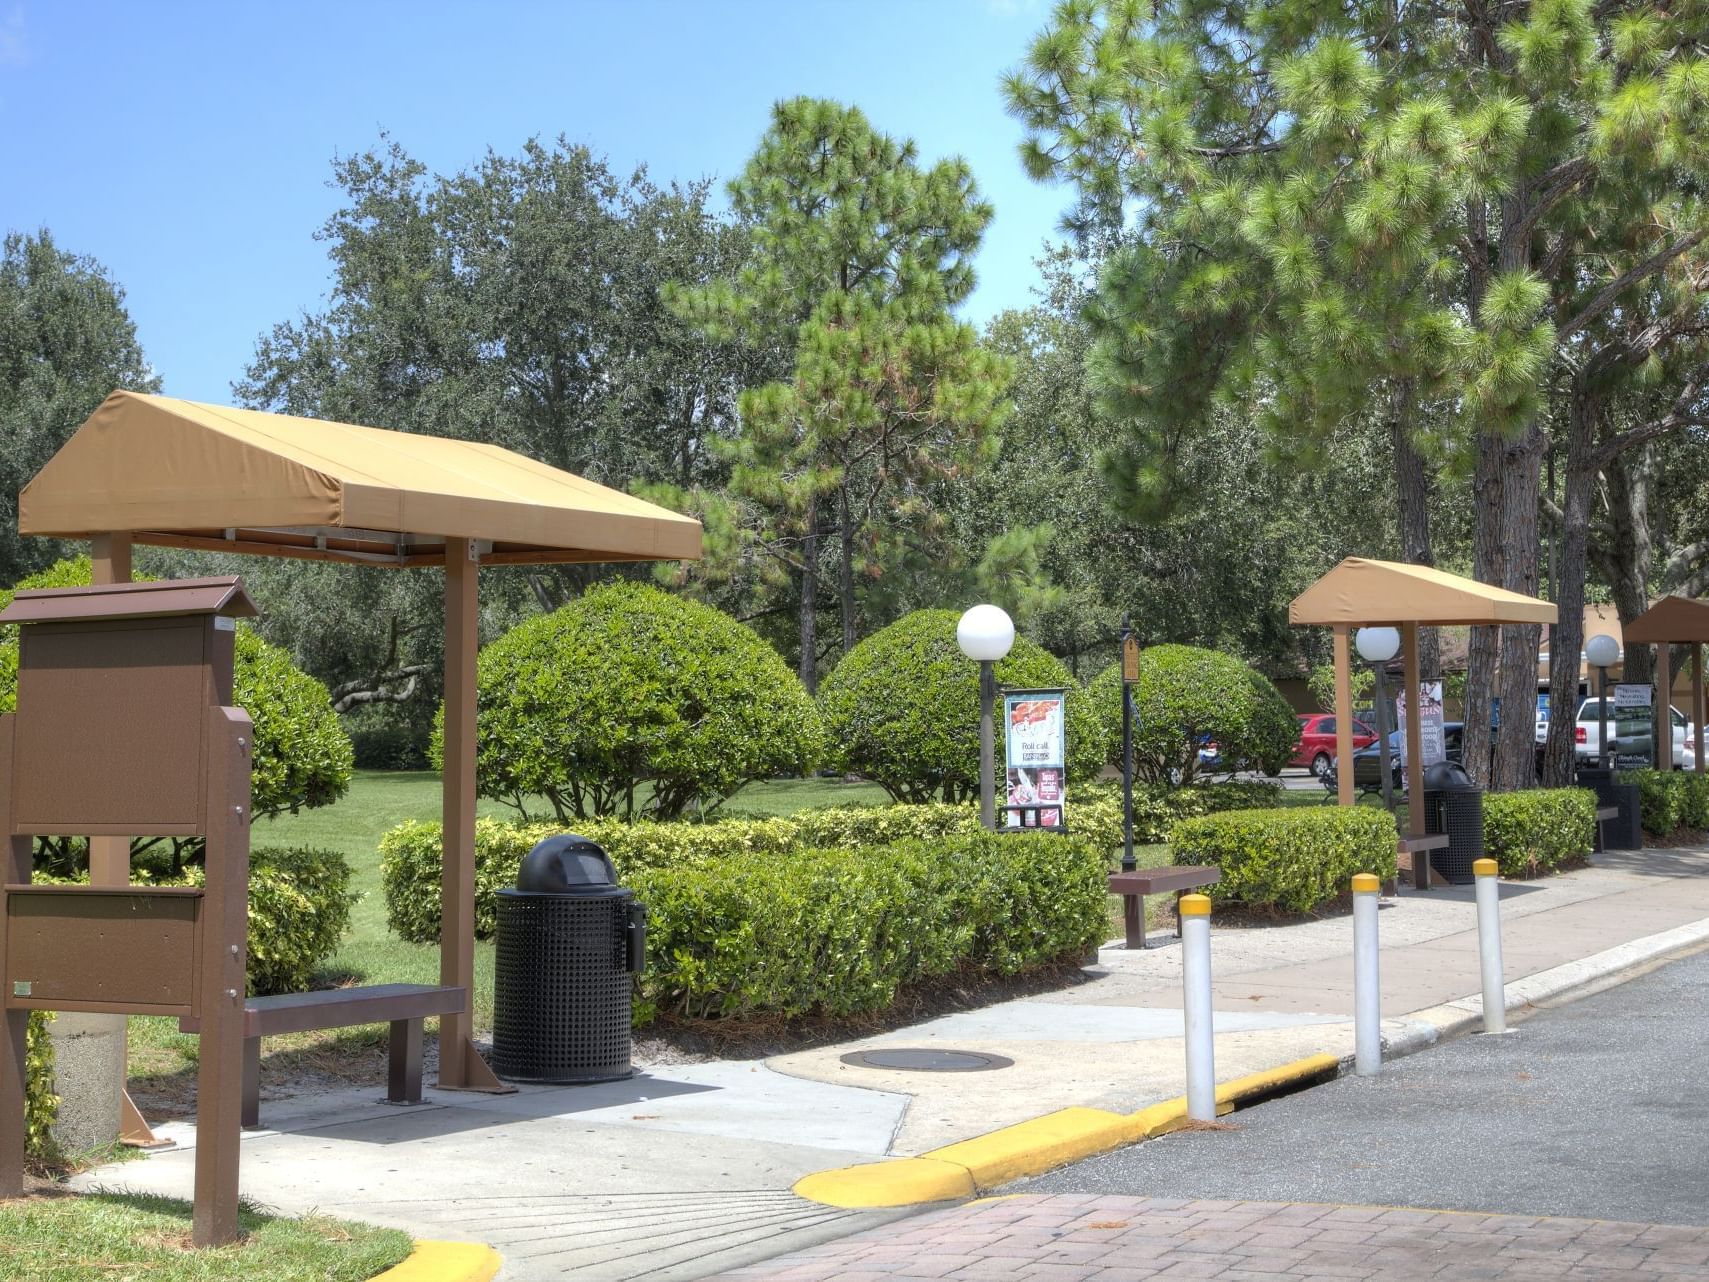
1287,557,1555,889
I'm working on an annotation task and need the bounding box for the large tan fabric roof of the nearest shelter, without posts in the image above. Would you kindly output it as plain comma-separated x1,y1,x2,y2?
17,391,701,566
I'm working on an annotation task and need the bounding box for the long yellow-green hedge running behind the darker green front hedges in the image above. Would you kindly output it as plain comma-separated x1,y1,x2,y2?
379,783,1280,944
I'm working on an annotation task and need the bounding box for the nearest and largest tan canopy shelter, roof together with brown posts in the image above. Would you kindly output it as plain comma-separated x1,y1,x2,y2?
19,391,701,1123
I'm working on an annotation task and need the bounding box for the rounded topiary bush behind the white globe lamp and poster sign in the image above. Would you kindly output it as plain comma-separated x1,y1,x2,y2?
819,610,1107,802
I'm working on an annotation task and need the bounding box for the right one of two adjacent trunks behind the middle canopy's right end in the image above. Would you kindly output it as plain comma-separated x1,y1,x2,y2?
1494,422,1548,790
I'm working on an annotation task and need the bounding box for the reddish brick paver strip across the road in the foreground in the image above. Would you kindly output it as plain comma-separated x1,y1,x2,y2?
719,1193,1709,1282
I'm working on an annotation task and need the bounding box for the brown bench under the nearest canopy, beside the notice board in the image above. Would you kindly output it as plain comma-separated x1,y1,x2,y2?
178,985,468,1126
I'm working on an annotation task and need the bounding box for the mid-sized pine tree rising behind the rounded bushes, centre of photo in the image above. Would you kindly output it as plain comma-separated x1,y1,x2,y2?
673,97,1008,689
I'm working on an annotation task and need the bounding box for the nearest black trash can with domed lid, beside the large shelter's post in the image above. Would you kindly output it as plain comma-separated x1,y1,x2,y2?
492,832,646,1082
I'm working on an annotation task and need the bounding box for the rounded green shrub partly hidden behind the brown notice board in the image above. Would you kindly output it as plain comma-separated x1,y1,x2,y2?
0,557,352,872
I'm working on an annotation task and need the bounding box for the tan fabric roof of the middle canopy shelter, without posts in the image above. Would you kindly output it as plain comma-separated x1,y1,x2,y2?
1287,557,1555,627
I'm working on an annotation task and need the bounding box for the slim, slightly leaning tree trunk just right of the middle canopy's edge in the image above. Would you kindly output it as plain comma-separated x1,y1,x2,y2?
1543,379,1600,788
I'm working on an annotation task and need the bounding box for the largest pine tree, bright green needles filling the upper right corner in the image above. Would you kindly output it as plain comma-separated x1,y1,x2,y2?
1007,0,1709,785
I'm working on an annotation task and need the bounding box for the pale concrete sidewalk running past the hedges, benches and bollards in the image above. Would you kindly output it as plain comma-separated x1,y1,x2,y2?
80,851,1709,1282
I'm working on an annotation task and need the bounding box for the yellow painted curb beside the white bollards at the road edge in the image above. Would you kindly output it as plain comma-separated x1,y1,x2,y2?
795,1055,1342,1207
